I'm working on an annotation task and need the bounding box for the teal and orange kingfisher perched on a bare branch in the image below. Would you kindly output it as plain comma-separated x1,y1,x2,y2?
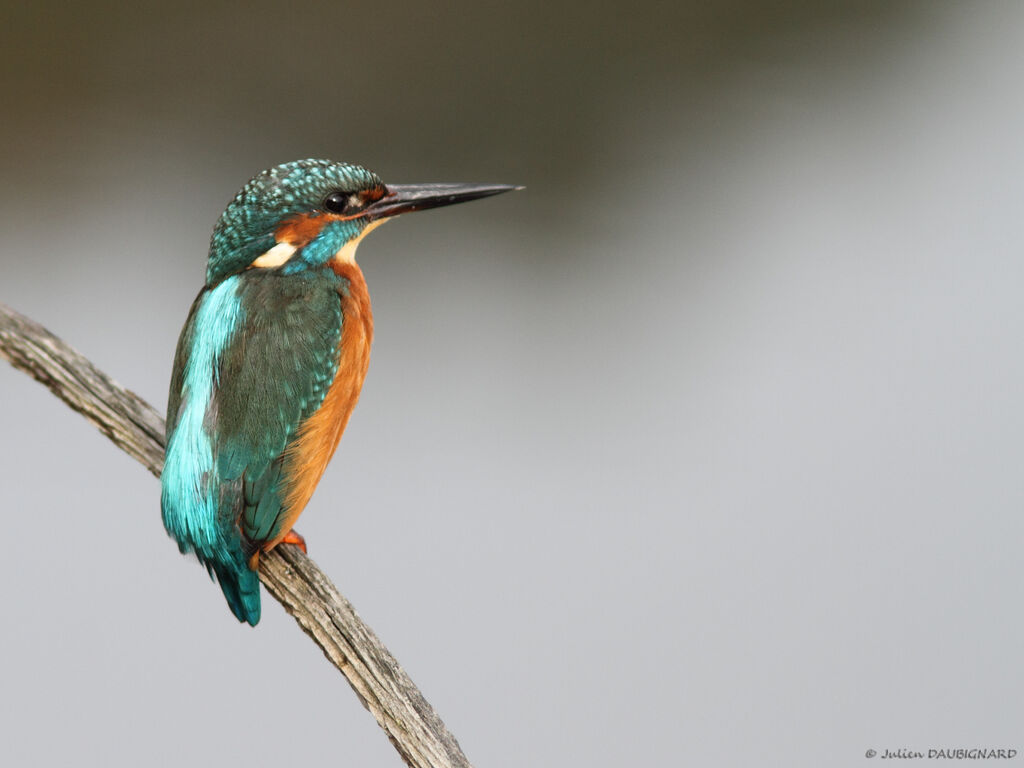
161,160,520,627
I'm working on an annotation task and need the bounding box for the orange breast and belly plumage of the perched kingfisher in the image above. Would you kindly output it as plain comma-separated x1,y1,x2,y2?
262,260,374,552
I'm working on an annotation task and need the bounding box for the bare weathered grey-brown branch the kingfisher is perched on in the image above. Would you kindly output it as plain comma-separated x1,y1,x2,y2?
0,304,470,768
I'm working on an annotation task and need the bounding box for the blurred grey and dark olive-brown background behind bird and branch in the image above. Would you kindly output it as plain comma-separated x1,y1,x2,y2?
0,0,1024,768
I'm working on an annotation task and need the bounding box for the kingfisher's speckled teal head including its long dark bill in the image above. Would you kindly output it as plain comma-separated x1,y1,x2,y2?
206,160,517,286
